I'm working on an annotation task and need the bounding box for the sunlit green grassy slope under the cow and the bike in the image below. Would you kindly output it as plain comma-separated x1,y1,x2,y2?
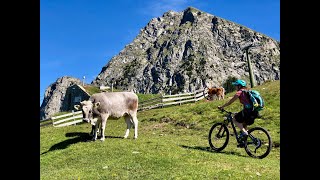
40,81,280,180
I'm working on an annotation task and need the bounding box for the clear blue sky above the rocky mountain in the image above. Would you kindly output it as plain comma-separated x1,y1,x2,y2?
40,0,280,105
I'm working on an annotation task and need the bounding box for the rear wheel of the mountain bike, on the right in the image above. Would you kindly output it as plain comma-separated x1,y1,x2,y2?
244,127,272,159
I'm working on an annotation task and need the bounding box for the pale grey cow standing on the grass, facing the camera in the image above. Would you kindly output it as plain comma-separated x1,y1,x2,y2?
74,92,138,141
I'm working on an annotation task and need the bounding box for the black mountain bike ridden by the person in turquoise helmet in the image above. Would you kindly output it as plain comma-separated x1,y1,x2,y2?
208,109,272,159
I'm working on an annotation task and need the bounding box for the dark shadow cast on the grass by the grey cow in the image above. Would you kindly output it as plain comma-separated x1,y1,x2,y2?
40,132,123,155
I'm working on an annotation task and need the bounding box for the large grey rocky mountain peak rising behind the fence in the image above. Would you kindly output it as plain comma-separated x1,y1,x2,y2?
92,7,280,93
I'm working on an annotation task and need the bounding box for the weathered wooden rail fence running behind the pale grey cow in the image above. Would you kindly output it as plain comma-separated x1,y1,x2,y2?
40,89,208,127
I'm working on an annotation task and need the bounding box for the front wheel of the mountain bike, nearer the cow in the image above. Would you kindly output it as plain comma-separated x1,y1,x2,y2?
208,123,229,152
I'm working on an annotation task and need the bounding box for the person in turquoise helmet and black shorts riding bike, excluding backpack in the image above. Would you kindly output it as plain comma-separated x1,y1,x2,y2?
218,79,258,147
